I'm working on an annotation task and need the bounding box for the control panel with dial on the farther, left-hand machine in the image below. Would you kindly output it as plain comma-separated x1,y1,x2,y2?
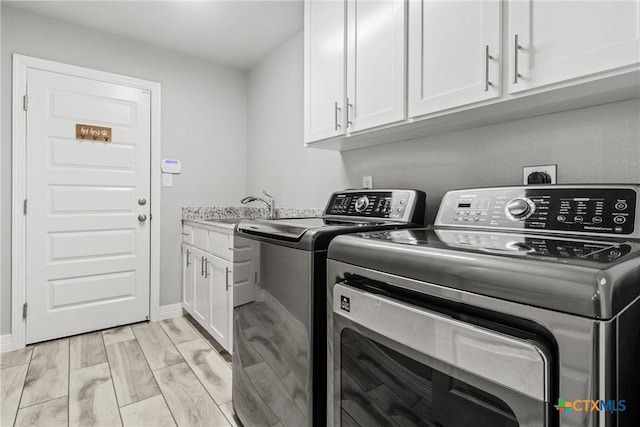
324,190,425,223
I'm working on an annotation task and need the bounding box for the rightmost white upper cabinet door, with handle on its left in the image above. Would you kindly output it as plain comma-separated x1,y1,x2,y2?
508,0,640,93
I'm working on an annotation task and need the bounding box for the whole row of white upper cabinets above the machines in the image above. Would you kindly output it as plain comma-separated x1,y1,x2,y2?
305,0,640,151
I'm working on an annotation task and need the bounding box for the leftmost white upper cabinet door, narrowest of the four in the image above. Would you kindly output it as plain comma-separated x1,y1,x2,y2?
304,0,345,142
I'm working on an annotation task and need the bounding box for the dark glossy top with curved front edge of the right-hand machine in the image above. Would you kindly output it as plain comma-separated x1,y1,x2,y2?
328,229,640,319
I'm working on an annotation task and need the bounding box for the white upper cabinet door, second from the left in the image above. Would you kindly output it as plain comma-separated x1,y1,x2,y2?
345,0,406,133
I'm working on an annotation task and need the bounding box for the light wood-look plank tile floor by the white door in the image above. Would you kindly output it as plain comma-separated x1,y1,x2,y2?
0,317,237,427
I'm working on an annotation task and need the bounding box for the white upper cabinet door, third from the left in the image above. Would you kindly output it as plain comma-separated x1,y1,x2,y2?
407,0,502,117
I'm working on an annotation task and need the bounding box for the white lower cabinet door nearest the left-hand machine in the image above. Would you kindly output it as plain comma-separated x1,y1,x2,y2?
206,256,233,352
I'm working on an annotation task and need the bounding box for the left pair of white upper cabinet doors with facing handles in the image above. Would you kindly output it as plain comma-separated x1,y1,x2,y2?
304,0,406,142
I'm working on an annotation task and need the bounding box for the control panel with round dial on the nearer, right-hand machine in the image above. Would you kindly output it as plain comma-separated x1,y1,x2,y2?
435,185,640,237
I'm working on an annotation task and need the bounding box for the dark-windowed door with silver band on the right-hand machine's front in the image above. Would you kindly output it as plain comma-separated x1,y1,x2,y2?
331,284,555,427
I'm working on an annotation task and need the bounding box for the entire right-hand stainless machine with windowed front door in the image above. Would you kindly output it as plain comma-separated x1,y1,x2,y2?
327,185,640,427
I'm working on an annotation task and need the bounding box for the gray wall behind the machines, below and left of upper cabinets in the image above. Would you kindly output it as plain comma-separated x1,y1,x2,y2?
247,31,640,222
